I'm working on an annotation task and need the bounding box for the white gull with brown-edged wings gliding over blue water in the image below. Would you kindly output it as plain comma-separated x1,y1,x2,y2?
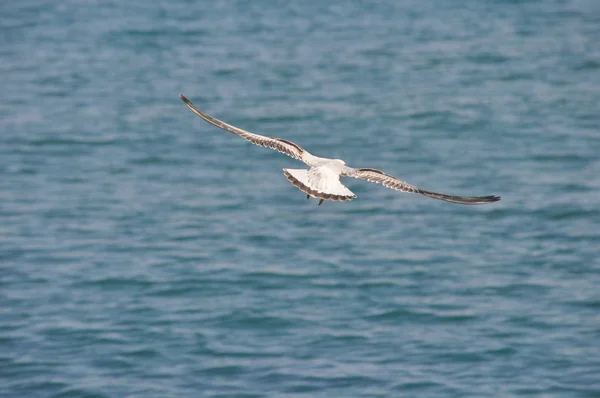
179,94,500,205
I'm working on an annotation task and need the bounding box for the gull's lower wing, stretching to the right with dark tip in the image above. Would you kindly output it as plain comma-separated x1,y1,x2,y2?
344,169,500,205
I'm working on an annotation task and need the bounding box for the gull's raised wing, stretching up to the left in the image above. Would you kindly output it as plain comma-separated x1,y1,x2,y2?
179,94,312,166
